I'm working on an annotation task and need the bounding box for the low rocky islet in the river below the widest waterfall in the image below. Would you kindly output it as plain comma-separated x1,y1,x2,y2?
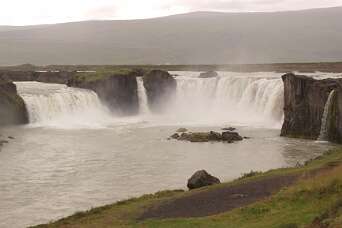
171,131,246,143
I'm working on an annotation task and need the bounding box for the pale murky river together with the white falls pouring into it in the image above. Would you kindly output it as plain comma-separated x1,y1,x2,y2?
0,72,333,227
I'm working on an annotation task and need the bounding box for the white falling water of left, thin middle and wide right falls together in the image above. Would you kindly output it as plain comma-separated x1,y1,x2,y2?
17,72,340,129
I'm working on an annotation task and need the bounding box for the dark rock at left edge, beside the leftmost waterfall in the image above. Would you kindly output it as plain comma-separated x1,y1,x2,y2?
0,76,28,126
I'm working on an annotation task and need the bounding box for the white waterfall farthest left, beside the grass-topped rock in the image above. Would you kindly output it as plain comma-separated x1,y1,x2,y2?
16,82,111,128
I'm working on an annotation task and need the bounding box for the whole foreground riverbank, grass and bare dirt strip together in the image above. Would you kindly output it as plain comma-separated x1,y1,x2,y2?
37,148,342,228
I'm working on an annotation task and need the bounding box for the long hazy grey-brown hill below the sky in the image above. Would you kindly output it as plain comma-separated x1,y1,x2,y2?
0,7,342,65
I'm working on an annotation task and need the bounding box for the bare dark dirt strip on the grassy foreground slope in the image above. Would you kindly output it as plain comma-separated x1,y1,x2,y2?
140,175,298,220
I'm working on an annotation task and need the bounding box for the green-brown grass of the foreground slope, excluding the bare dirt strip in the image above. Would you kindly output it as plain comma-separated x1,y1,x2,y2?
34,149,342,228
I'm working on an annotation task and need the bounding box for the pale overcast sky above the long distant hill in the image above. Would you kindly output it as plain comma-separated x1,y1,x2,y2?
0,0,342,25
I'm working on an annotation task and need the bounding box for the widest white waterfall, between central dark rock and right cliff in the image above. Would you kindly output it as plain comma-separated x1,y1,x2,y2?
156,72,284,128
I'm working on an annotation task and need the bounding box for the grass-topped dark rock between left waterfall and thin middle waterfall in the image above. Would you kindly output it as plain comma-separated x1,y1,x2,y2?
67,71,139,115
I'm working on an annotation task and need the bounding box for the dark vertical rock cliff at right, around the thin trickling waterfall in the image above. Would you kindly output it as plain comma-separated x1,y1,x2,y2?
281,73,342,142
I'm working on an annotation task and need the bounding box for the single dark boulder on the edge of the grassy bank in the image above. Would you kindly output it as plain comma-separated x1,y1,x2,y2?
187,170,221,190
